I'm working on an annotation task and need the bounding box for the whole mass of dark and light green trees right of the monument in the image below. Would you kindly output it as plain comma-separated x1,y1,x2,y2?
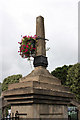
51,63,80,101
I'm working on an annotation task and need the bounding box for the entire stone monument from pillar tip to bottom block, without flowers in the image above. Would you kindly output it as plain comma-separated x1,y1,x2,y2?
3,16,73,120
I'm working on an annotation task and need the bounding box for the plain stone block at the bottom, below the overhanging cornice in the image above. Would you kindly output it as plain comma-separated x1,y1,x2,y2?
12,104,68,118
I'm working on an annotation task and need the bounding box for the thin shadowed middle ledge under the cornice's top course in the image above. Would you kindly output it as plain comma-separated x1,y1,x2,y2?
4,94,69,101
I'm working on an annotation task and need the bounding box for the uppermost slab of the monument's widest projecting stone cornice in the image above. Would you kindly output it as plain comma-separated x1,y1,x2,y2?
3,87,73,98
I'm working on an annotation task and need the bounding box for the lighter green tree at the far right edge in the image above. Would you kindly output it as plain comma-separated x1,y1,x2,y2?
66,63,80,101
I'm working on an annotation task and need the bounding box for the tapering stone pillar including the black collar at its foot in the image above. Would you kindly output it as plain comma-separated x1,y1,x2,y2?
33,16,48,68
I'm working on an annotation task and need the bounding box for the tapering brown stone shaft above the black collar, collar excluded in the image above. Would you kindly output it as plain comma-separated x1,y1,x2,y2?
36,16,46,56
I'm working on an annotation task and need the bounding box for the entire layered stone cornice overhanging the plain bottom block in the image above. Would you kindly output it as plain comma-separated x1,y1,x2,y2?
3,85,73,105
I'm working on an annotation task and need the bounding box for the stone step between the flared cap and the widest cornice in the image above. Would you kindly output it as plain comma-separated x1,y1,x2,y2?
8,81,70,93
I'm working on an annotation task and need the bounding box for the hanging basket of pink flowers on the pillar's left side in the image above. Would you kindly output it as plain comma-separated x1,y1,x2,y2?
18,35,37,60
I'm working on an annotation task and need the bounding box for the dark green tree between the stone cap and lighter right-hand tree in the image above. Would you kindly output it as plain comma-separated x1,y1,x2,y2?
51,65,72,85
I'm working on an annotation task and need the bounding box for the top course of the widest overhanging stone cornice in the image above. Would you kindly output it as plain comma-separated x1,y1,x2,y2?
3,87,73,97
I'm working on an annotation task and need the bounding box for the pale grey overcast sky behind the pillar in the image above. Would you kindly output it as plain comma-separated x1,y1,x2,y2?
0,0,78,81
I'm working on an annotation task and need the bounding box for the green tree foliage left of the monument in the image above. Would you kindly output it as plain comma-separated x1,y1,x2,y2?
2,74,22,91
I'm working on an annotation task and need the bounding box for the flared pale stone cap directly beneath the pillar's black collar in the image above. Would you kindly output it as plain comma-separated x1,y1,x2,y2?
20,66,61,85
